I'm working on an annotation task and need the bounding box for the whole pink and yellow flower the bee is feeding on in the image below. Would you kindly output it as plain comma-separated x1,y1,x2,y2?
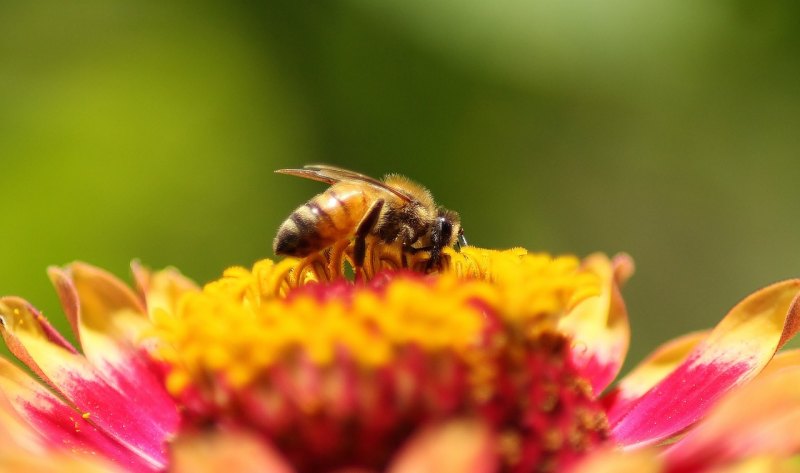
0,241,800,473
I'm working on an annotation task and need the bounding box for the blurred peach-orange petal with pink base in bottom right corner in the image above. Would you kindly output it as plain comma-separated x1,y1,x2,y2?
664,366,800,472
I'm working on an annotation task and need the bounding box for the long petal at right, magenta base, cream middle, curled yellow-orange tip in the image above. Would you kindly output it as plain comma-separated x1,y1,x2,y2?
612,279,800,446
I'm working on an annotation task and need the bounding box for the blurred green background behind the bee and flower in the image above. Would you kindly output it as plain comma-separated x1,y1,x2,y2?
0,0,800,370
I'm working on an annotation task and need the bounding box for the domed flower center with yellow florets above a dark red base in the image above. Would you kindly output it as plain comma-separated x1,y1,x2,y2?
156,245,606,471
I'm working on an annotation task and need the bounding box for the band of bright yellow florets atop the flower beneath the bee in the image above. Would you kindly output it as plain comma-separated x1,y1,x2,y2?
156,246,598,393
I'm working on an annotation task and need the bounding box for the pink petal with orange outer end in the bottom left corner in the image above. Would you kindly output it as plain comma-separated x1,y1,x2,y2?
0,358,155,471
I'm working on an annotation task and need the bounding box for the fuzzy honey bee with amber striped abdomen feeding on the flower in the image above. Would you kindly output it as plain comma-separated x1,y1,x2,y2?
272,164,467,270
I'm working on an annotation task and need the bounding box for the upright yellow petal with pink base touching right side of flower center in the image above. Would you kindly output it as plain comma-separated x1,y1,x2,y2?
559,253,633,395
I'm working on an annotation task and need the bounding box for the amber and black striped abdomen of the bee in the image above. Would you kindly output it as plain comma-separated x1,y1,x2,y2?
272,182,375,256
